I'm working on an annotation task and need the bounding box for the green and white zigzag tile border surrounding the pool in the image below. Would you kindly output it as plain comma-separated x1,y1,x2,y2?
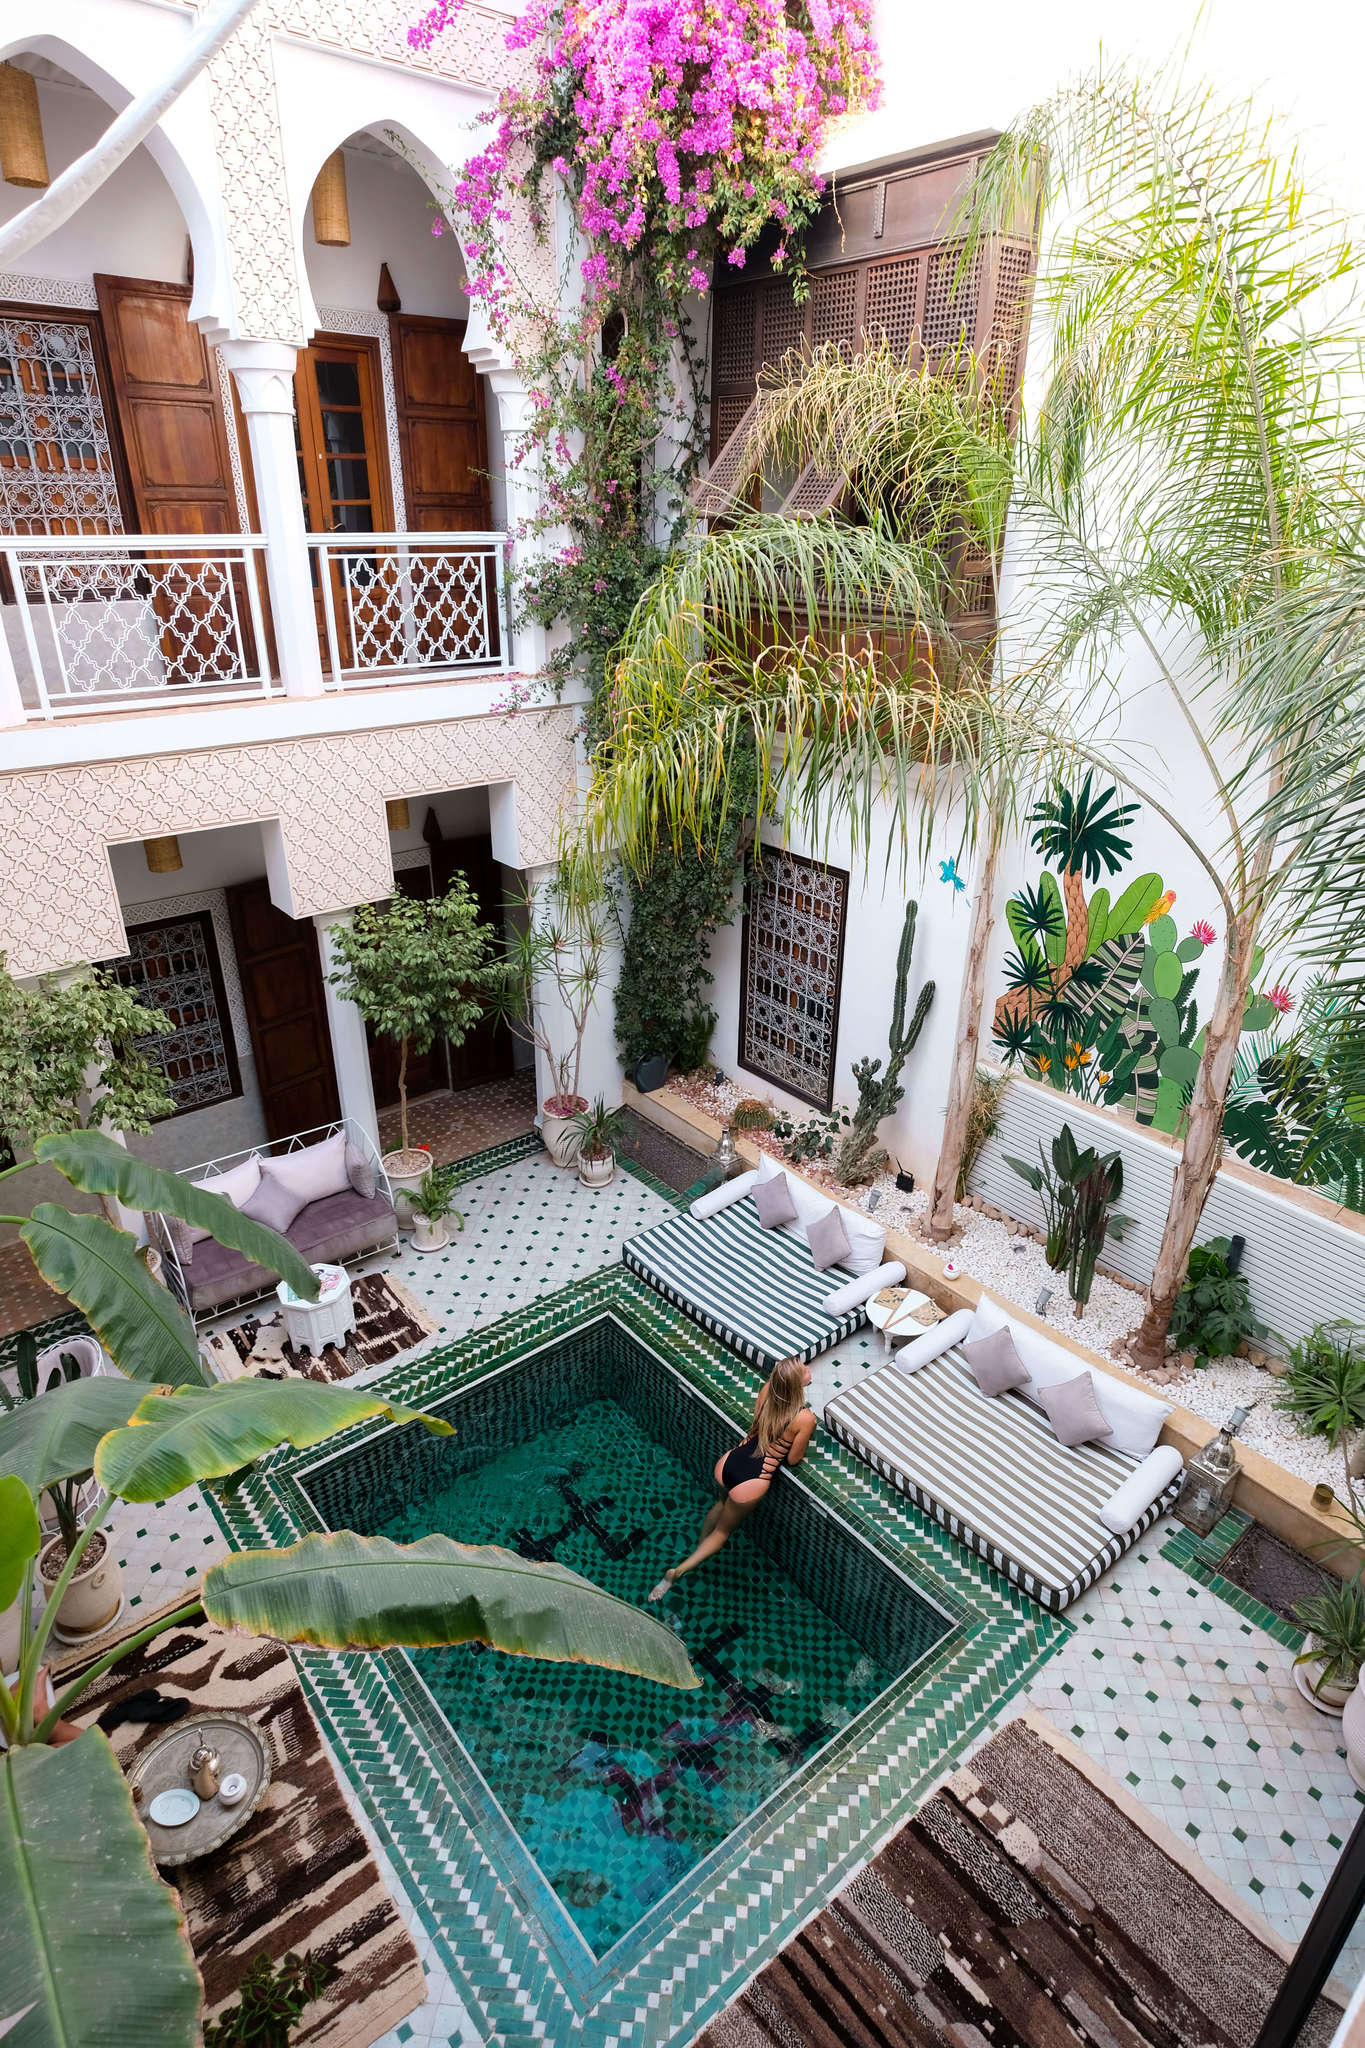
213,1137,1074,2048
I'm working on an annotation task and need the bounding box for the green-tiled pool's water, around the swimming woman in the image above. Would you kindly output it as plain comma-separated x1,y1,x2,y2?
305,1319,950,1954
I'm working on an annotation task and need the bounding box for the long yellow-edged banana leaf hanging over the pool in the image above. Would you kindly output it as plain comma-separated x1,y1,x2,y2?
203,1530,702,1690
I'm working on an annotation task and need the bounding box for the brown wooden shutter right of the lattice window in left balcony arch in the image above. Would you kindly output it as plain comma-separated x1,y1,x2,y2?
94,276,237,532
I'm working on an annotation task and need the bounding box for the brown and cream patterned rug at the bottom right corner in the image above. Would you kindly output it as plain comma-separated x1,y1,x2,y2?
696,1714,1340,2048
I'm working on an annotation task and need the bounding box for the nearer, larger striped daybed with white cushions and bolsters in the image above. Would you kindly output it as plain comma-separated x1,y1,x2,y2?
825,1294,1183,1612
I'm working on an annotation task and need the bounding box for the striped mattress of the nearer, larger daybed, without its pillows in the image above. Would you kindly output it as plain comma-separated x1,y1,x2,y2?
825,1348,1179,1610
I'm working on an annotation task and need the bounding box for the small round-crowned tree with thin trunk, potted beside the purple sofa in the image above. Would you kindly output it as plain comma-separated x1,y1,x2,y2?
327,874,489,1151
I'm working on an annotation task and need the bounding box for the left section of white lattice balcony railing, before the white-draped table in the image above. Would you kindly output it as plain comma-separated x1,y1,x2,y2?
0,532,280,719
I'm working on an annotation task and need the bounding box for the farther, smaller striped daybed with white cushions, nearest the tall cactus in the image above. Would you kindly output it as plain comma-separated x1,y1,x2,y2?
622,1155,905,1372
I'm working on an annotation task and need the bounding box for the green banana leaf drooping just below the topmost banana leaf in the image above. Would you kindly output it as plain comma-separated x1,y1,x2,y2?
18,1202,205,1386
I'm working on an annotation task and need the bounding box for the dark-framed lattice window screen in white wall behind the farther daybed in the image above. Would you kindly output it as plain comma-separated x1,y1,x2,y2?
739,848,849,1110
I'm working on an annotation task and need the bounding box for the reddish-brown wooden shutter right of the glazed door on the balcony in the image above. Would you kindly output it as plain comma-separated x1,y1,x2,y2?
389,313,493,532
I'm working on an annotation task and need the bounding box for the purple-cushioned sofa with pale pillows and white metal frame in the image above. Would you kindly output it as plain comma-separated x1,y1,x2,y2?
147,1116,399,1323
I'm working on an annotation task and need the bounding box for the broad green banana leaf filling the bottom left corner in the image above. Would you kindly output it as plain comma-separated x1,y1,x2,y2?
0,1729,203,2048
